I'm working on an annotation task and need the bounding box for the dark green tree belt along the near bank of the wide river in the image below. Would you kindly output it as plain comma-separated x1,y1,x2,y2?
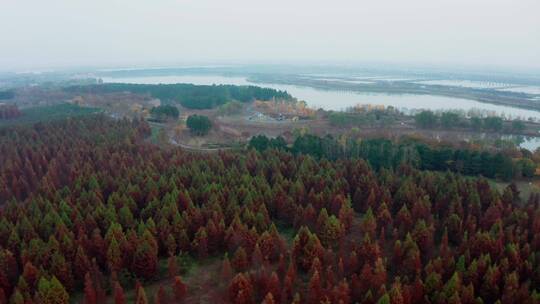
65,83,292,109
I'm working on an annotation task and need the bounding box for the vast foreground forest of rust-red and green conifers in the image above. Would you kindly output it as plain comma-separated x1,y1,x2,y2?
0,115,540,304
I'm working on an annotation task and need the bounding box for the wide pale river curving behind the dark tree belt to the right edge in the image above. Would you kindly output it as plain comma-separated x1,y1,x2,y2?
102,75,540,120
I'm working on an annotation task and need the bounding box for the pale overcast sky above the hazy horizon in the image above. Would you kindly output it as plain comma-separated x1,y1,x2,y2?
0,0,540,70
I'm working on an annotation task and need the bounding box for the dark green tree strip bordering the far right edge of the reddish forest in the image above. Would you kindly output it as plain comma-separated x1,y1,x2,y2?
249,134,536,180
